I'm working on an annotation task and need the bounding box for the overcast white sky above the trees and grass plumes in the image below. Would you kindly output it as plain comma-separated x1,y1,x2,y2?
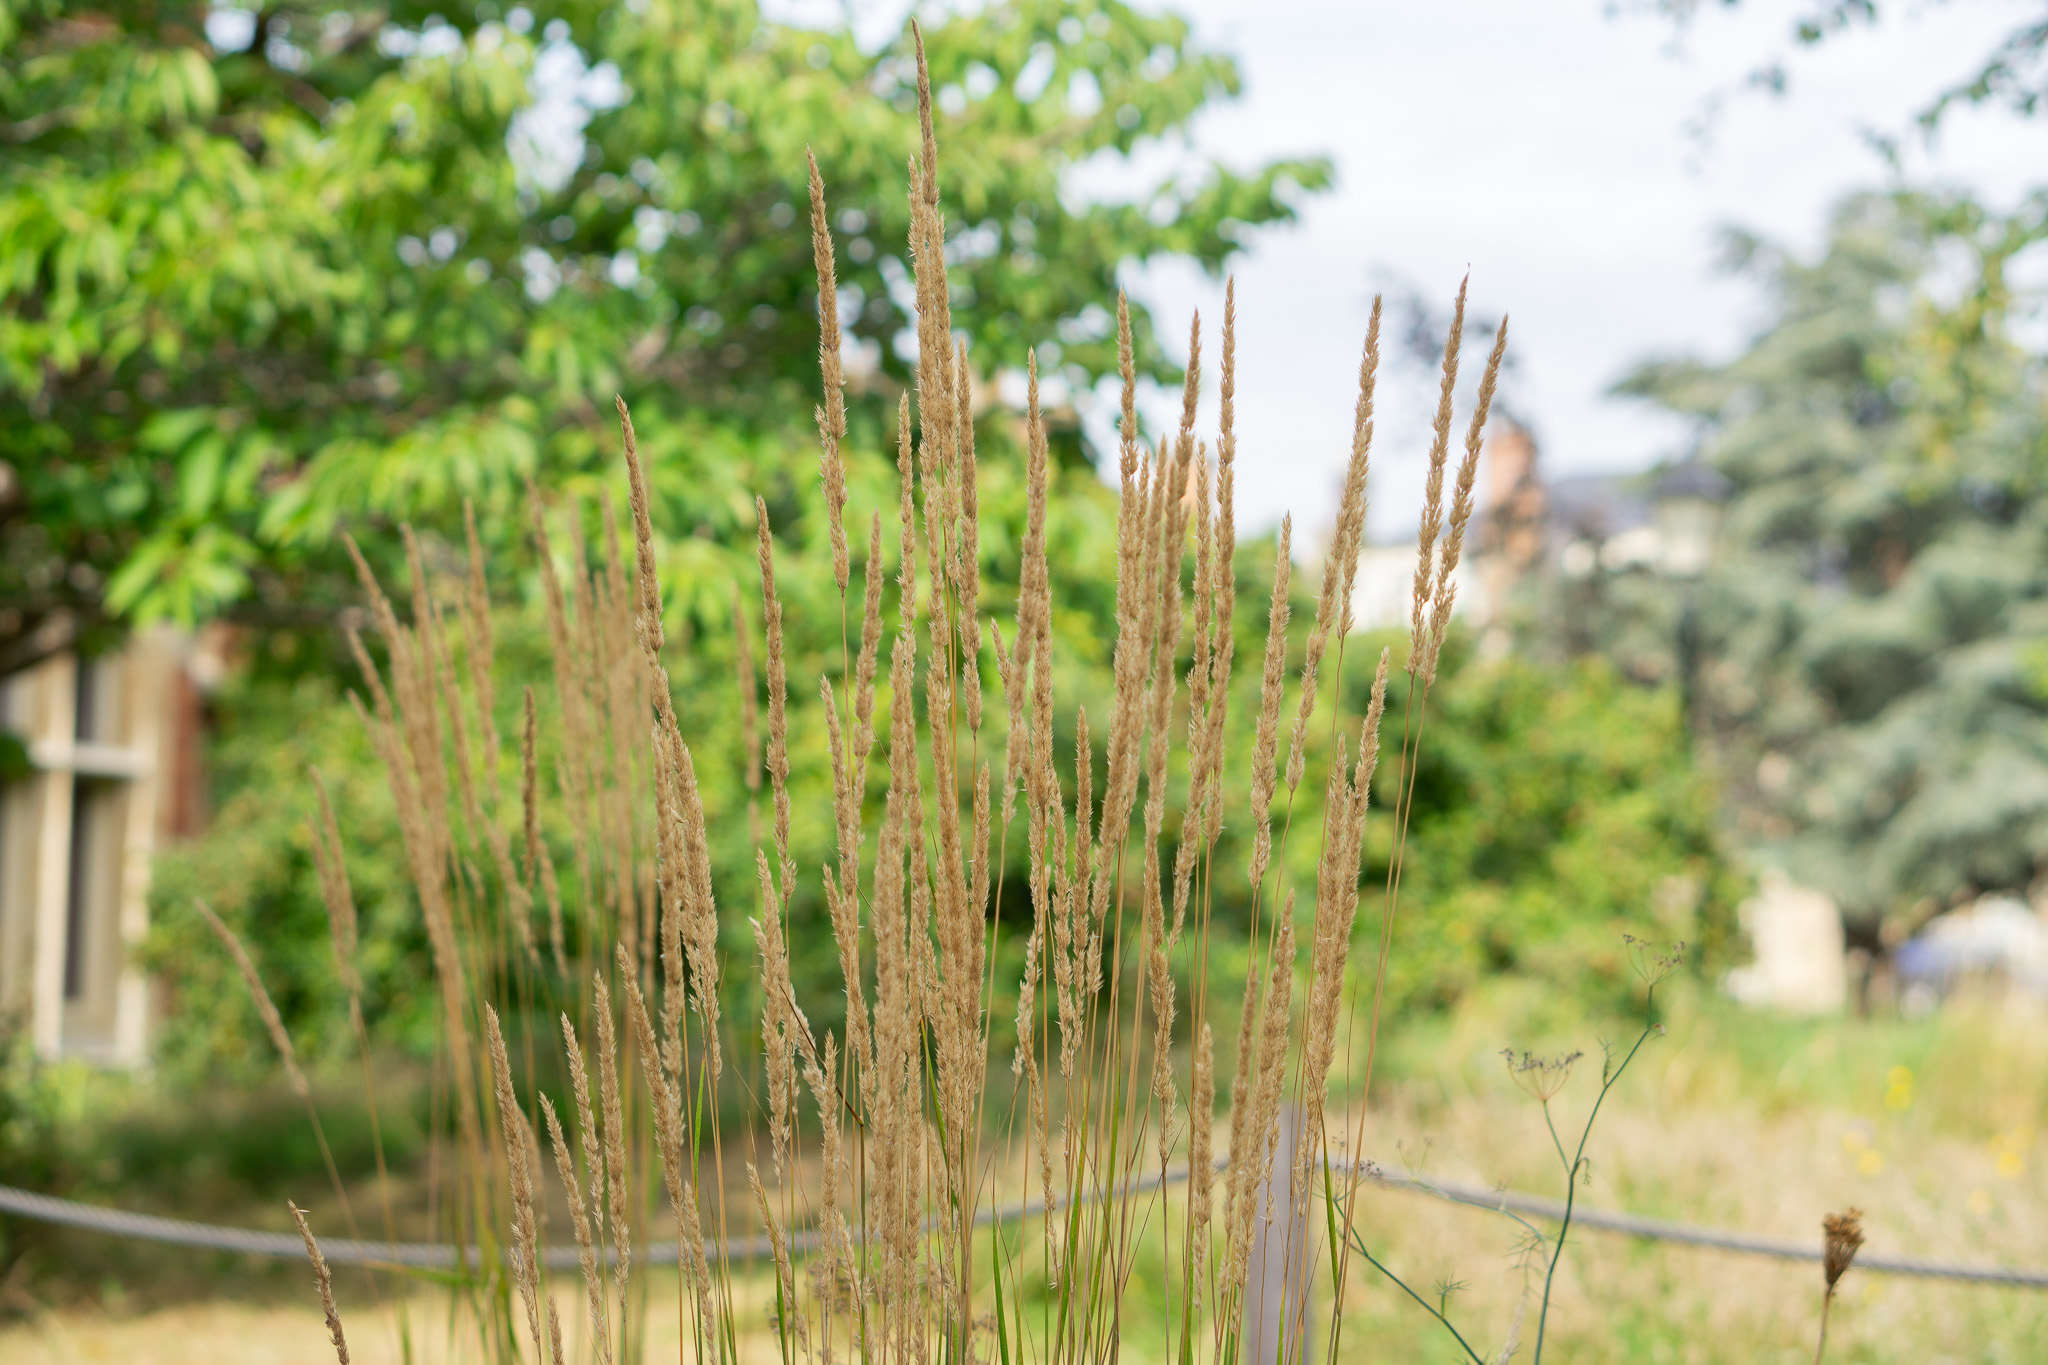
768,0,2048,538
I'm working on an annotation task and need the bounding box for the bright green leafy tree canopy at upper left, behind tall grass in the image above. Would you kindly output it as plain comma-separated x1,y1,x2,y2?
0,0,1327,673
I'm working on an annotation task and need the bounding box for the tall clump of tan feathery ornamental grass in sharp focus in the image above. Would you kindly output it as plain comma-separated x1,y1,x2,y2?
228,24,1564,1365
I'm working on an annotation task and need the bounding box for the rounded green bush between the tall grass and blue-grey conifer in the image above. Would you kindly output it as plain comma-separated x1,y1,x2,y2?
1362,649,1737,1009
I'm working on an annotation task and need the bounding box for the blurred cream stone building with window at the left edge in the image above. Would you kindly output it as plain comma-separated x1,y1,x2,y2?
0,630,207,1064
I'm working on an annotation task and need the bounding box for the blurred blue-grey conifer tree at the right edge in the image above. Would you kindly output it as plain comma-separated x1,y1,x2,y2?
1624,192,2048,923
